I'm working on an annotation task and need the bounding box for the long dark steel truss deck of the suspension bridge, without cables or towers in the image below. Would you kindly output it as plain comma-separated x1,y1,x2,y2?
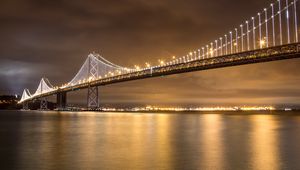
23,43,300,102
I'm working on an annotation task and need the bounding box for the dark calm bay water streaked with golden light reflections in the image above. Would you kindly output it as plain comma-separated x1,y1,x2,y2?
0,111,300,170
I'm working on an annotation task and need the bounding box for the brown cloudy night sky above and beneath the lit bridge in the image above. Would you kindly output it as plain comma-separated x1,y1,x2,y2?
0,0,300,106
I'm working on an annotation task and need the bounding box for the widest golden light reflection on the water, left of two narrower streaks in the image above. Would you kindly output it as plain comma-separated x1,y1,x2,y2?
76,112,172,169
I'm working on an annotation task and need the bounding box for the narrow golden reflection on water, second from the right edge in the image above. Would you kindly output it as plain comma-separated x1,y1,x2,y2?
200,114,224,169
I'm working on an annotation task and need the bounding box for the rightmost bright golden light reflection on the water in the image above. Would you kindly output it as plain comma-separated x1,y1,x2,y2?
250,115,280,170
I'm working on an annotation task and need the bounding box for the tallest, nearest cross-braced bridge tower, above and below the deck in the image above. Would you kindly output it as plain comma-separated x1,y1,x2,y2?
87,54,99,110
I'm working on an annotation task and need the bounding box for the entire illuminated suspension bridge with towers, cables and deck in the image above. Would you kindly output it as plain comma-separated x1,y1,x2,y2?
20,0,300,109
